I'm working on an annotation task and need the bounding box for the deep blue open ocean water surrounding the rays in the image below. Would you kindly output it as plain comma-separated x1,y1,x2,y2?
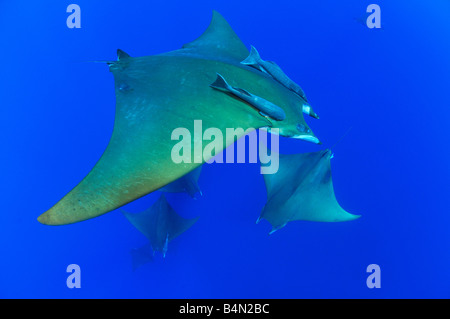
0,0,450,298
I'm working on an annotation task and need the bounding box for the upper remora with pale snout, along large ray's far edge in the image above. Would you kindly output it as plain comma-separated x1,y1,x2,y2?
241,46,319,119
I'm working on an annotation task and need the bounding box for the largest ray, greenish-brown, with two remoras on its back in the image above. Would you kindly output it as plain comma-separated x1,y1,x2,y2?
38,12,318,225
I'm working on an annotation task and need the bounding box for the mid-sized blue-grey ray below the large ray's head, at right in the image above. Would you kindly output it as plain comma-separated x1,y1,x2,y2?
257,149,360,234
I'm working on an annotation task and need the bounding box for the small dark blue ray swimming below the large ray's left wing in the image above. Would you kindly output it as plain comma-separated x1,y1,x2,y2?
123,194,198,257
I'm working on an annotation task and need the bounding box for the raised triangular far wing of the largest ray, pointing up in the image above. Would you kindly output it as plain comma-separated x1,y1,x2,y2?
183,10,248,62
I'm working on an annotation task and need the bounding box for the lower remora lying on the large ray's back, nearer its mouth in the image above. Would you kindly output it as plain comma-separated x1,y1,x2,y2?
210,73,286,121
